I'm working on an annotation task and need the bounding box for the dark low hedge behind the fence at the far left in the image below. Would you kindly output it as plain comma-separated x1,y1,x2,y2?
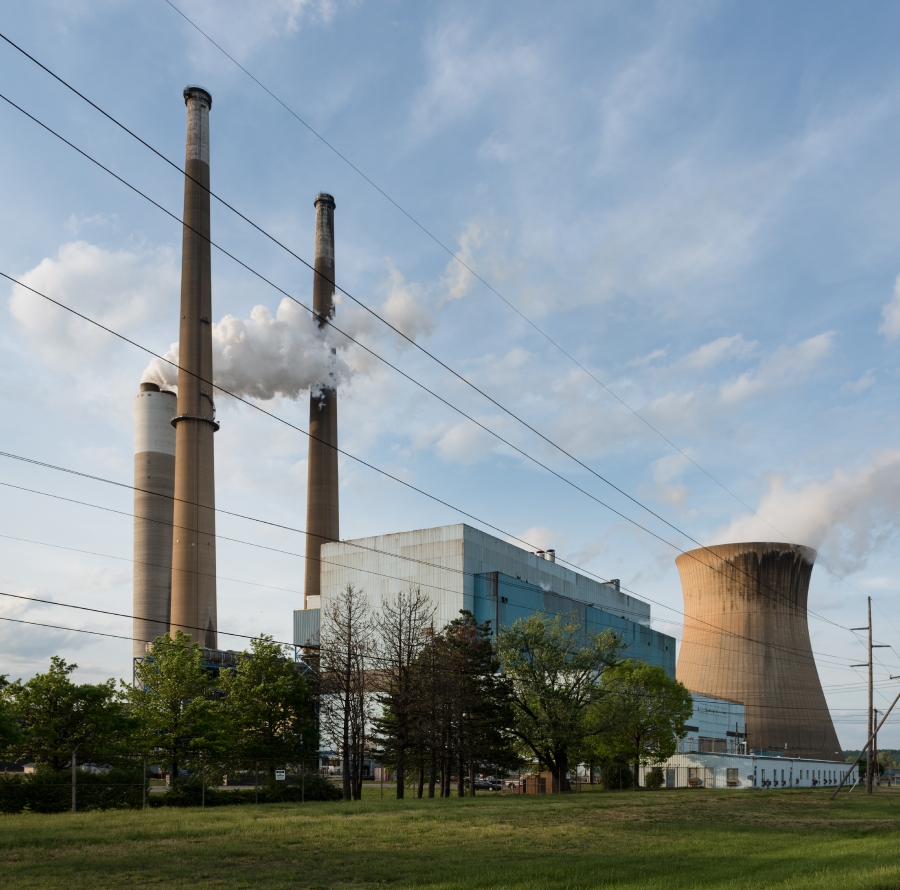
0,767,143,813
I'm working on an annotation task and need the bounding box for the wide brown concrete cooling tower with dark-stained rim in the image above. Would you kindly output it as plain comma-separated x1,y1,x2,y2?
675,543,841,760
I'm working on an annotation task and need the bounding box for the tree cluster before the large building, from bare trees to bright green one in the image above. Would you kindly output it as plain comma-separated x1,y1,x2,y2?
318,585,693,800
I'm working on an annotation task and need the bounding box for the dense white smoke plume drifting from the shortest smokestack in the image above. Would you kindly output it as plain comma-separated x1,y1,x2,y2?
142,297,354,401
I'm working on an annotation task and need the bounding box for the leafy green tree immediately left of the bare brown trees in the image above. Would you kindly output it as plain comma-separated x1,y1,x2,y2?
218,635,318,779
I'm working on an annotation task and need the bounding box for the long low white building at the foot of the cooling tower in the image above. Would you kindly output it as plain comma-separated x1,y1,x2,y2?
640,751,859,789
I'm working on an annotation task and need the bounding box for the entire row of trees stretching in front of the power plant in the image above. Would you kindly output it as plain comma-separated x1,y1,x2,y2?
0,585,692,800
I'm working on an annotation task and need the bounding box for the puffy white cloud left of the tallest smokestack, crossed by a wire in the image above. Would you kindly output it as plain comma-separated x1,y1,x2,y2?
9,241,180,364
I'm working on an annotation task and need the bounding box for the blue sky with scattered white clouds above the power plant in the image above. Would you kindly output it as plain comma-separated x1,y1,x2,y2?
0,0,900,748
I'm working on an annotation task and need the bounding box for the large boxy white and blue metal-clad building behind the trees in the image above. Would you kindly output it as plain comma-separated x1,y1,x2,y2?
294,524,675,677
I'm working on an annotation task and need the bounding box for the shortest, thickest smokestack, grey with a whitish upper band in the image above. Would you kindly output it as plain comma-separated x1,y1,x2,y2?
131,383,176,658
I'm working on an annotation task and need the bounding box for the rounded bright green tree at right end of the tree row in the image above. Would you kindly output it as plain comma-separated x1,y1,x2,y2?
593,660,694,787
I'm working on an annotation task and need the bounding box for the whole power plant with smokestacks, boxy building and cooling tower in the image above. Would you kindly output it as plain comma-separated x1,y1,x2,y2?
125,87,841,787
